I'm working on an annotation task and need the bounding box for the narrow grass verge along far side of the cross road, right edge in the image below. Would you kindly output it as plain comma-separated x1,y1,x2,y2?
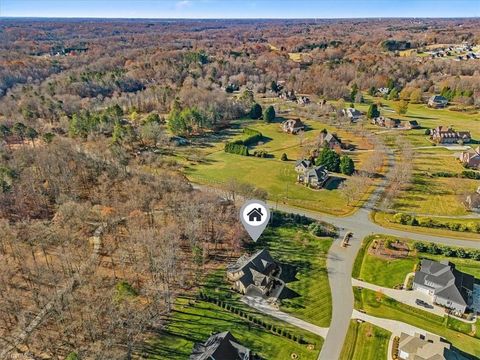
372,212,480,240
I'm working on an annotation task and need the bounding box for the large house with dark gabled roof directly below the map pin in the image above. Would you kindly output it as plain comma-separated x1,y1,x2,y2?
227,249,281,296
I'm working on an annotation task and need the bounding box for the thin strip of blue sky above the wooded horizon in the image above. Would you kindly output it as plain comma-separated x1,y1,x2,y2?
0,0,480,18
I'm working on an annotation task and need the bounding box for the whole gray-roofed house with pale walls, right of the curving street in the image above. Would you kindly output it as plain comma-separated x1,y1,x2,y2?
413,259,475,315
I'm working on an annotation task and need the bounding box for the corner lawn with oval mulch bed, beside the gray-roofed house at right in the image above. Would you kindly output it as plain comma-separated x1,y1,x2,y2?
352,235,480,288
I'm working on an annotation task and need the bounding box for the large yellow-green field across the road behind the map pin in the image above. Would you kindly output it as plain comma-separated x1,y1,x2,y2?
184,114,371,215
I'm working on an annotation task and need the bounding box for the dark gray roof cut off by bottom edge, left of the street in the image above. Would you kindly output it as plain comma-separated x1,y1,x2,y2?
189,331,251,360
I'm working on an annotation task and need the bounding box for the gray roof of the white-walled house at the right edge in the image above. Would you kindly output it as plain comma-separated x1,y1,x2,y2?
413,259,475,306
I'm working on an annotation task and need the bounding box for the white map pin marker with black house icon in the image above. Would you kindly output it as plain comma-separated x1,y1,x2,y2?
240,199,270,241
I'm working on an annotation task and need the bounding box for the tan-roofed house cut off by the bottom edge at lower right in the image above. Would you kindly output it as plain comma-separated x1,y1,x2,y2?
398,332,467,360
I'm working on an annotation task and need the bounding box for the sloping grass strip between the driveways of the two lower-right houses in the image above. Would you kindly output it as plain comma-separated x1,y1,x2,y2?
354,288,480,358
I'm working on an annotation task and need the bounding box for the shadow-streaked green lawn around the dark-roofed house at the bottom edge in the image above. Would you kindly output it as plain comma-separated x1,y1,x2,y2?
145,298,323,360
